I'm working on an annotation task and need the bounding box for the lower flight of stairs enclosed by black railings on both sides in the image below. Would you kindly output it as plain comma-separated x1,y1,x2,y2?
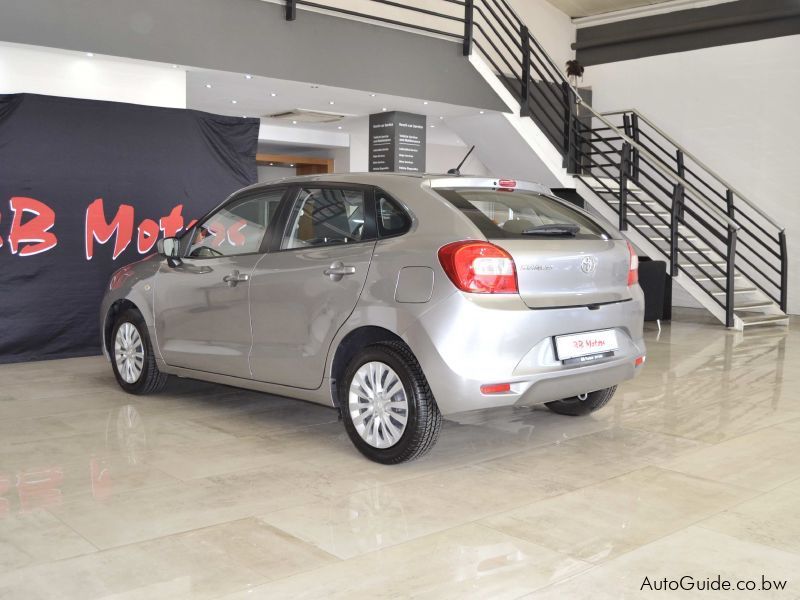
574,110,788,329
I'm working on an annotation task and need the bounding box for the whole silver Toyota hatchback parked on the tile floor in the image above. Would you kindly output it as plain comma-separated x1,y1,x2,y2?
100,174,645,463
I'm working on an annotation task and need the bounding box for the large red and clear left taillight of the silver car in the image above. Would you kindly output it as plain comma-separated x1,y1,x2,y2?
439,241,518,294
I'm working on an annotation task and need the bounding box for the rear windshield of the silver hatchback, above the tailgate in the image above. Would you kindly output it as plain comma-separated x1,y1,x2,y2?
436,188,610,239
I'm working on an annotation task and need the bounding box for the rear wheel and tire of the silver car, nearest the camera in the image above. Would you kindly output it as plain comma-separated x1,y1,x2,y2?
337,342,442,464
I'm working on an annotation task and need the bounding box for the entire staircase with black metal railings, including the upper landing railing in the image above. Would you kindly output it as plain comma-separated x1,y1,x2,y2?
285,0,789,330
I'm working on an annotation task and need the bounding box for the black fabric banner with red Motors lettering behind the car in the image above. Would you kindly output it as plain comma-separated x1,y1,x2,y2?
0,94,259,362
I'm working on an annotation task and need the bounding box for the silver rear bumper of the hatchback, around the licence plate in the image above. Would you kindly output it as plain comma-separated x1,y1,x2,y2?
403,286,645,414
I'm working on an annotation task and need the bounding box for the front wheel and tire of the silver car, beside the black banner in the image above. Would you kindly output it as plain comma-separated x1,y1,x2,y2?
109,309,169,395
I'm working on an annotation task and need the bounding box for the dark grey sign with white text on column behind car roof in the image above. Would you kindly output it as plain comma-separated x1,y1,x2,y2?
369,111,427,173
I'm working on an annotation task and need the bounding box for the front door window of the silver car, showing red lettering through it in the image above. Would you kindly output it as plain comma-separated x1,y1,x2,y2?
187,190,284,258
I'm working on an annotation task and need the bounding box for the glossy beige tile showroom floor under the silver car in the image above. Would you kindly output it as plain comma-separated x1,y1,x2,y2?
0,320,800,600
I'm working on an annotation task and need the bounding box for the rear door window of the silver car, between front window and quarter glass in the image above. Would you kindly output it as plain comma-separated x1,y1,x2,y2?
281,188,366,250
